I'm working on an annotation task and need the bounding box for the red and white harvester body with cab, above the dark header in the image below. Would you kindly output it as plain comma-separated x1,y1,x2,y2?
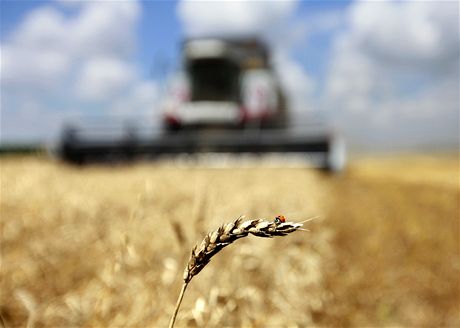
164,39,286,131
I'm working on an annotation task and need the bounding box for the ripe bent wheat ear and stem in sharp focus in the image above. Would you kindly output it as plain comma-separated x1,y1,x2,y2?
169,217,303,328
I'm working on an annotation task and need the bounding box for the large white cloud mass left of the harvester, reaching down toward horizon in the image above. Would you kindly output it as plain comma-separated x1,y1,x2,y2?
1,1,157,140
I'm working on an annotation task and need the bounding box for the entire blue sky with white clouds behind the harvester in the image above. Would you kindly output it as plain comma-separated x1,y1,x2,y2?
0,0,460,149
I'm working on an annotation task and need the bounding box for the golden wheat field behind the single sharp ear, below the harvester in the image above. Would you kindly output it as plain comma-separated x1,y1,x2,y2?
0,156,460,327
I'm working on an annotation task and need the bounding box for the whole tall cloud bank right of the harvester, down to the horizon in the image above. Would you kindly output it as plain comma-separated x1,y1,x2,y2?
323,1,460,149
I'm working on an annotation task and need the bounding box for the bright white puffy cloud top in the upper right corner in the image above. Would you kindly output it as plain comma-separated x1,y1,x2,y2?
349,1,459,66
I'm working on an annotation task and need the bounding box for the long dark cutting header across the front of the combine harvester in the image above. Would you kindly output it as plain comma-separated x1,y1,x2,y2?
60,130,344,169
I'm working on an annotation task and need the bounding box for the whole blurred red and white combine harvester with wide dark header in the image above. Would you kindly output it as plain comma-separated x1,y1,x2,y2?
59,38,345,171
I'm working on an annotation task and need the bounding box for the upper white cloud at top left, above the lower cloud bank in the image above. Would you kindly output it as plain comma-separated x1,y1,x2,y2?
2,2,140,86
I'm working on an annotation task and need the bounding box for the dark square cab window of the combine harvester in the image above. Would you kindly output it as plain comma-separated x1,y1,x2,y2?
188,58,240,102
